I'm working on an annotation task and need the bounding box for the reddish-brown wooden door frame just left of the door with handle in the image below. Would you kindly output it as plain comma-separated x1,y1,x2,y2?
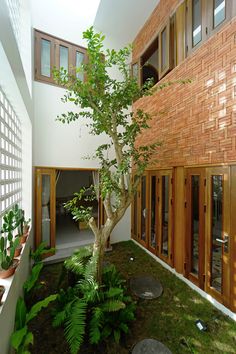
185,167,206,289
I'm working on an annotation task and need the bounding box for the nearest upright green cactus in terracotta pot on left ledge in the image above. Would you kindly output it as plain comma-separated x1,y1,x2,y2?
0,236,19,279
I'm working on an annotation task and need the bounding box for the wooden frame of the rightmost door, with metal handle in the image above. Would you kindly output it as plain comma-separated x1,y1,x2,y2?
205,166,230,307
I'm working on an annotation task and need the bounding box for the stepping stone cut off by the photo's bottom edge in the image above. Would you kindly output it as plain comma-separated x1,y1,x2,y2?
132,339,172,354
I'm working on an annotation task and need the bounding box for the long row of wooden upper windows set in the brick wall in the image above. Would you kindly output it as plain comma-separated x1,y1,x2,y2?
132,0,236,90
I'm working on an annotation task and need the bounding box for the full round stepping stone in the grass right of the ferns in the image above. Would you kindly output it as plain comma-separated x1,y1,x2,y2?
130,275,163,300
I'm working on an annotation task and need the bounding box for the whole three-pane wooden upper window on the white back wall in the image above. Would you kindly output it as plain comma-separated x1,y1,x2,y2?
35,30,86,84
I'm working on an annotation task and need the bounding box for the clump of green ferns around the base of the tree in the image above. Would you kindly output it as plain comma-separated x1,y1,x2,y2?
53,248,136,354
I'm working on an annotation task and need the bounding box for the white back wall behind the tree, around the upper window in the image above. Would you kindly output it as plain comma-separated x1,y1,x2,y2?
31,0,130,242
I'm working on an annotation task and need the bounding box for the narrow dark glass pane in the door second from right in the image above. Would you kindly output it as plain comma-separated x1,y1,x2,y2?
191,176,199,275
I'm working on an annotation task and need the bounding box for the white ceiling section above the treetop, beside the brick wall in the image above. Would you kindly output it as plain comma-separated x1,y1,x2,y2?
94,0,160,44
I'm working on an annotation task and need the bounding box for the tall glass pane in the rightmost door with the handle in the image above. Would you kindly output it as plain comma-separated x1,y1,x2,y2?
211,176,223,292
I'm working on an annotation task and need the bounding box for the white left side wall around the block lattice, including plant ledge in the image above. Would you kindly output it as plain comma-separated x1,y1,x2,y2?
0,0,33,354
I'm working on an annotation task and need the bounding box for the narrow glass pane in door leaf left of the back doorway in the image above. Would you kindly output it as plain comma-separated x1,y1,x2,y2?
42,175,51,246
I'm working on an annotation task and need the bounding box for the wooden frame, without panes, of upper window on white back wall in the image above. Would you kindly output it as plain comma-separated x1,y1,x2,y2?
34,29,87,86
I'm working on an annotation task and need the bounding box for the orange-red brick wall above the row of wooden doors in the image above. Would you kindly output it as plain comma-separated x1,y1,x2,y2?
133,0,236,167
